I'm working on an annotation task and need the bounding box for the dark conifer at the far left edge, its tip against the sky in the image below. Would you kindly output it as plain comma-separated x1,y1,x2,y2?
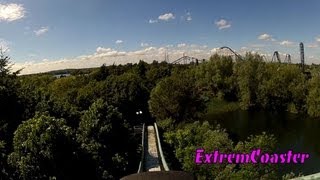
0,49,23,179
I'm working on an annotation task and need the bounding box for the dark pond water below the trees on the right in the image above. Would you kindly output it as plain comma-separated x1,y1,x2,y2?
207,111,320,175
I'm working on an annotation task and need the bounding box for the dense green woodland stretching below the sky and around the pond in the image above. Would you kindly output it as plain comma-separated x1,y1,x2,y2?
0,51,320,180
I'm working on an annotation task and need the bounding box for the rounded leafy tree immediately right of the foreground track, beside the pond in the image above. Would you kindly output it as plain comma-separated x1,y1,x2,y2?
164,122,233,179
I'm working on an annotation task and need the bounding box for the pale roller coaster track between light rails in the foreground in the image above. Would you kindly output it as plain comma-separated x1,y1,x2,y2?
138,123,169,173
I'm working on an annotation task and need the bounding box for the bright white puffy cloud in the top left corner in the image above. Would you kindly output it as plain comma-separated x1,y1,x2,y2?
0,3,25,22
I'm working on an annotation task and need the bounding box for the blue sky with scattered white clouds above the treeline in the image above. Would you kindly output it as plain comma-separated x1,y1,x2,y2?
0,0,320,74
